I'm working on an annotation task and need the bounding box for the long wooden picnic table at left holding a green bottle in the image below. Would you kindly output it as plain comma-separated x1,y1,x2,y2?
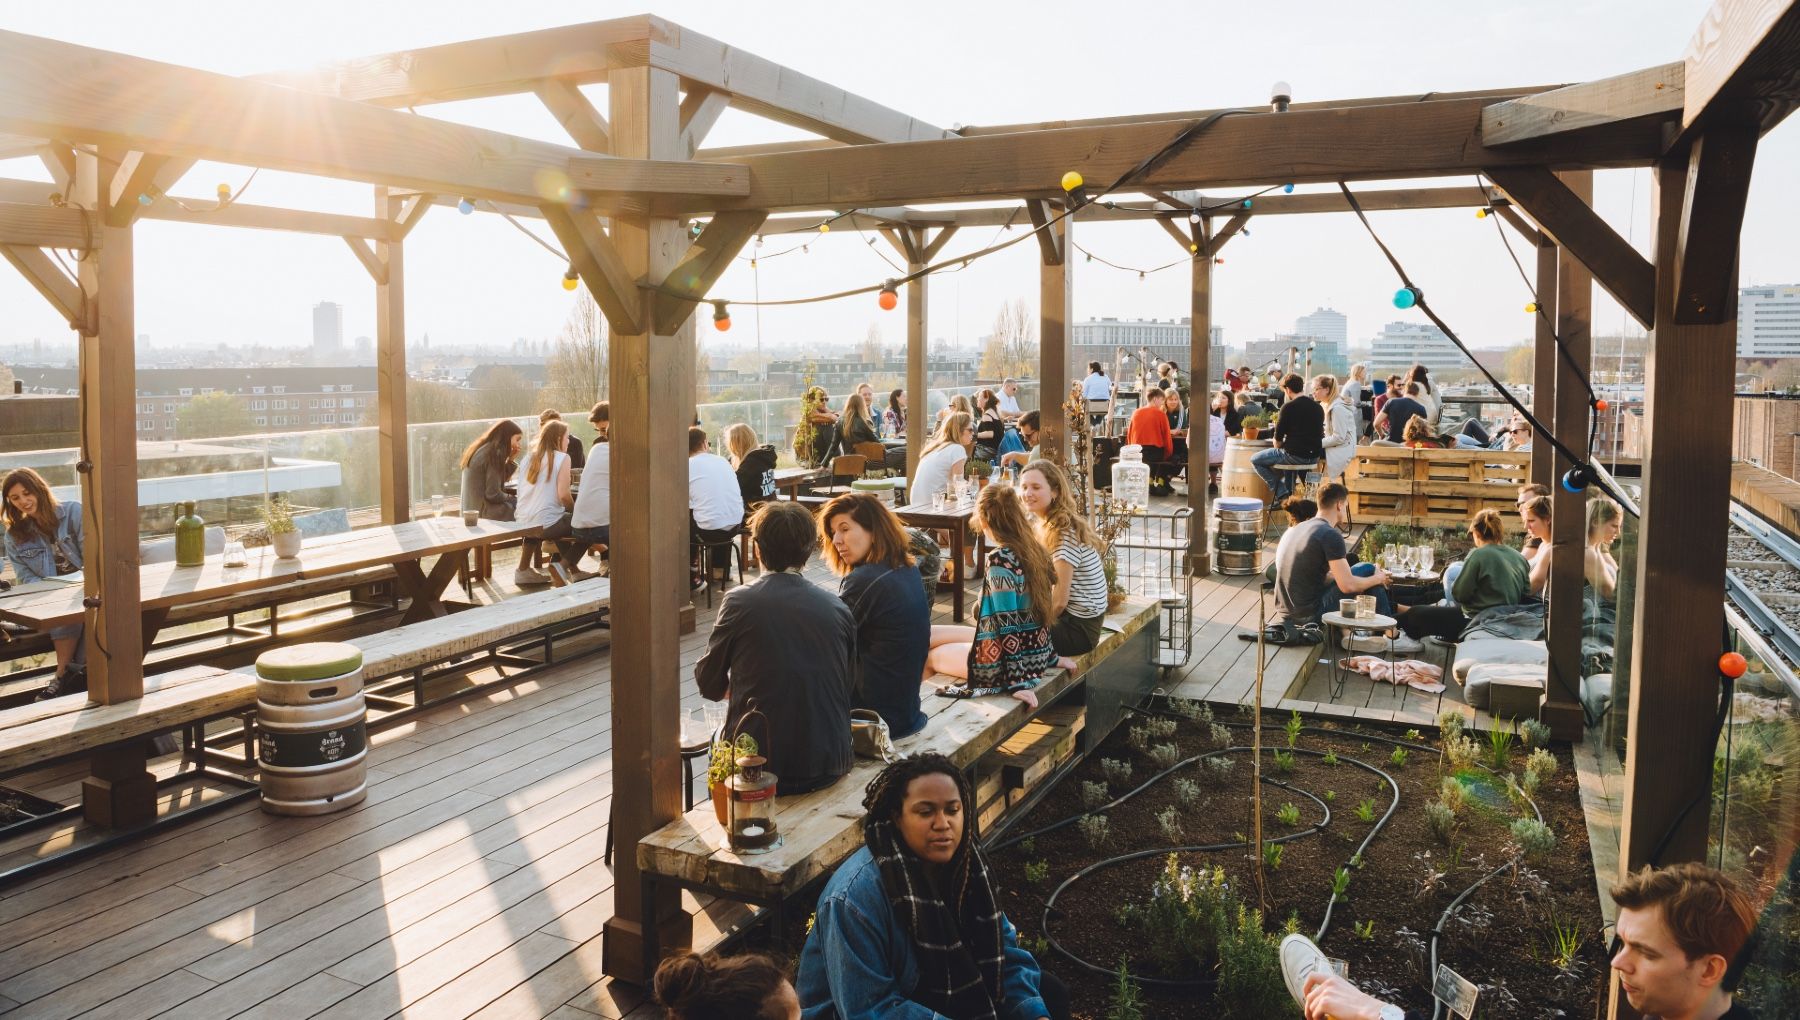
0,516,538,648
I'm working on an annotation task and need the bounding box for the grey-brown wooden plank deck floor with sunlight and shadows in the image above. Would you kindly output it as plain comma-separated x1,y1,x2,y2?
0,503,1504,1020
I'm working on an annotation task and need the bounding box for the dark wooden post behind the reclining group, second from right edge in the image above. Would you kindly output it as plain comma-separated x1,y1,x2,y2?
1532,171,1593,739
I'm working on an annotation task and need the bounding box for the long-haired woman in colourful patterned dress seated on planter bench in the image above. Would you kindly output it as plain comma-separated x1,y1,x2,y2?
927,482,1075,709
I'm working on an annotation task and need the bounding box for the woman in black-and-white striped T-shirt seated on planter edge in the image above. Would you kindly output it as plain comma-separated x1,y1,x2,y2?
1019,461,1107,655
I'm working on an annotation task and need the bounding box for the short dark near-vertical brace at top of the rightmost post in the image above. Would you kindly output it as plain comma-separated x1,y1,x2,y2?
1674,117,1759,326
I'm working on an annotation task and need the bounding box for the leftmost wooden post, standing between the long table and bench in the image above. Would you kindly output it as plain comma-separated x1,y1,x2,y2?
74,148,157,826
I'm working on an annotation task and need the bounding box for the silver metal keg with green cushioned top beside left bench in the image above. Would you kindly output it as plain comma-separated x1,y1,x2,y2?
256,642,369,815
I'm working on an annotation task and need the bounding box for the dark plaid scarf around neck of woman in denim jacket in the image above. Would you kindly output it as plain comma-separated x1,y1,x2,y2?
862,820,1004,1020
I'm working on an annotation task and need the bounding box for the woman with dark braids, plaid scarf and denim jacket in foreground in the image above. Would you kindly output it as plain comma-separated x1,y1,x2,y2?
797,754,1069,1020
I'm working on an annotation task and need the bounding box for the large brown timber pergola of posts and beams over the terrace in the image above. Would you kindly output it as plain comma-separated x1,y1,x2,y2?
0,0,1800,1007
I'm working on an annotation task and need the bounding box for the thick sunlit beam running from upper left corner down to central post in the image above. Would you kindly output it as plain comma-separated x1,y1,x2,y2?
0,32,608,201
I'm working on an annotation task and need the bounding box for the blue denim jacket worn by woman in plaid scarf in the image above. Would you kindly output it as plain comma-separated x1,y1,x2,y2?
796,847,1048,1020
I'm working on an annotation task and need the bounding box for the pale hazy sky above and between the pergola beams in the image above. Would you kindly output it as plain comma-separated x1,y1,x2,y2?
0,0,1800,361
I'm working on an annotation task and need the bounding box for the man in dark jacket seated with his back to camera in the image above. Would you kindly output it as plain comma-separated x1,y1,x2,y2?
693,502,857,795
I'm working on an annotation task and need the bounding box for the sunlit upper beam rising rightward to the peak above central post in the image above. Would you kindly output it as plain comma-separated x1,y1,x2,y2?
256,16,653,108
